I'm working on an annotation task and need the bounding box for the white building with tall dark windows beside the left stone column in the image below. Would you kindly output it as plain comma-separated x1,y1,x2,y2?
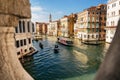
15,19,35,58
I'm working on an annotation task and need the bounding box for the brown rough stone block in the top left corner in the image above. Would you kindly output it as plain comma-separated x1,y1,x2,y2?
0,0,31,18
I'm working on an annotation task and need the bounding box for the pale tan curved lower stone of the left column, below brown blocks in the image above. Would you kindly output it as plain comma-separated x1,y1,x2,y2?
0,27,33,80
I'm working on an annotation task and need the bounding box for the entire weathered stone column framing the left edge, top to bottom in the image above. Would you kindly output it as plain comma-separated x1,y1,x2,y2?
0,0,33,80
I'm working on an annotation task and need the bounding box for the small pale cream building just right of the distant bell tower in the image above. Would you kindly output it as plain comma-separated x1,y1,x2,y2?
47,21,59,36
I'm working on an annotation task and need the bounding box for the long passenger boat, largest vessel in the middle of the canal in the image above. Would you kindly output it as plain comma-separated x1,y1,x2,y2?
57,37,73,46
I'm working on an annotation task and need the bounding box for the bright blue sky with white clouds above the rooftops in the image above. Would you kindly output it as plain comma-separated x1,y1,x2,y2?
30,0,108,22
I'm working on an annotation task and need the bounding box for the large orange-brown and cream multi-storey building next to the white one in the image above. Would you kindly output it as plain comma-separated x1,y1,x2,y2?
75,4,106,41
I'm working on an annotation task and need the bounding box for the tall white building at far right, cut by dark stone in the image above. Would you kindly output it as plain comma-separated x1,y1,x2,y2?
106,0,120,43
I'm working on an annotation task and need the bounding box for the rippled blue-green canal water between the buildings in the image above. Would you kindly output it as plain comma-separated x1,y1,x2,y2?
22,37,109,80
